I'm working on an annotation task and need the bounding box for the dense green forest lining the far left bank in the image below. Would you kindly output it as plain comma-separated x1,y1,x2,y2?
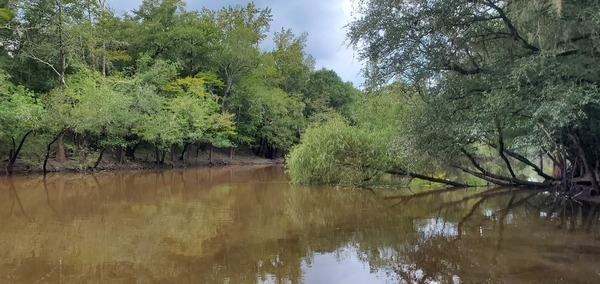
0,0,361,173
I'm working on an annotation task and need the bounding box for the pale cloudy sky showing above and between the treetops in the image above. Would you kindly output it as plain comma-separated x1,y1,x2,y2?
107,0,364,87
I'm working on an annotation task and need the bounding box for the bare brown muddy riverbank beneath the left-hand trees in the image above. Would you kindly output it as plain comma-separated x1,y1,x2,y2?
0,151,284,174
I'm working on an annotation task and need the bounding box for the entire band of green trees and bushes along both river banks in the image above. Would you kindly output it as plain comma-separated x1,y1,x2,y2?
0,0,600,200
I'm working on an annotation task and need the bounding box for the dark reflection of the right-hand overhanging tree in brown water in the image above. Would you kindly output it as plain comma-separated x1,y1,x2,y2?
370,188,600,283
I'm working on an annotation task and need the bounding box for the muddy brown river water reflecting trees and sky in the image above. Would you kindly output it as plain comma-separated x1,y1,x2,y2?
0,166,600,283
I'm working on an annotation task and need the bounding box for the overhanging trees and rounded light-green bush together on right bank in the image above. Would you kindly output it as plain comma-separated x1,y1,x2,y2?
288,0,600,197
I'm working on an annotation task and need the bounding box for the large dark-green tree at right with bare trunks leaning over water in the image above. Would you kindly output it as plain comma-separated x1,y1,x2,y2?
349,0,600,193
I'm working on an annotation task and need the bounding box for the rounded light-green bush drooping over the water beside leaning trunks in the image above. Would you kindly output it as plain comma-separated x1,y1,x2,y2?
287,87,417,185
